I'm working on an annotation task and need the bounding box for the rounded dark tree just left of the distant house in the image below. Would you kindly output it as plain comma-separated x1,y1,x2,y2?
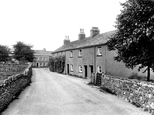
13,41,34,62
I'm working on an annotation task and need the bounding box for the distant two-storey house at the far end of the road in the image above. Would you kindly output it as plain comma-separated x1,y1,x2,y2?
33,49,51,67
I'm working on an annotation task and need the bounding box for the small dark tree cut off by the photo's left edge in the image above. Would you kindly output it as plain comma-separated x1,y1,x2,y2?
0,45,10,62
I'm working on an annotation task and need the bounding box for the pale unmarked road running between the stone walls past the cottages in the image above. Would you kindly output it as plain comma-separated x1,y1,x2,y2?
2,69,149,115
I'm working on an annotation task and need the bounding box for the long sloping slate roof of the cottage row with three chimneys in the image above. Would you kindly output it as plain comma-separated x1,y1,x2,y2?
52,30,116,53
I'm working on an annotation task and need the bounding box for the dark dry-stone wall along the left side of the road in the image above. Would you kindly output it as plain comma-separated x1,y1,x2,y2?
0,64,32,113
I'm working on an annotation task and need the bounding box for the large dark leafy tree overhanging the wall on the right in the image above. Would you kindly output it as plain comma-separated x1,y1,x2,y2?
108,0,154,81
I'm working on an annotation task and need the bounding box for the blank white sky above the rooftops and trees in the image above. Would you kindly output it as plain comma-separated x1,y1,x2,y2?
0,0,126,51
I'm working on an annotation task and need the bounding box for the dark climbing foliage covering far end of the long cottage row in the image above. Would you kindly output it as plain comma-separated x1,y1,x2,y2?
49,56,65,73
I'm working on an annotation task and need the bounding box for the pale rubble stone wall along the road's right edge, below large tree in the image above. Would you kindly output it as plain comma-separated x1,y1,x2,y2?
101,75,154,113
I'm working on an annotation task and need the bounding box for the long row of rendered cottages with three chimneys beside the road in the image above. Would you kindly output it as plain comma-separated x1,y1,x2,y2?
52,27,150,78
